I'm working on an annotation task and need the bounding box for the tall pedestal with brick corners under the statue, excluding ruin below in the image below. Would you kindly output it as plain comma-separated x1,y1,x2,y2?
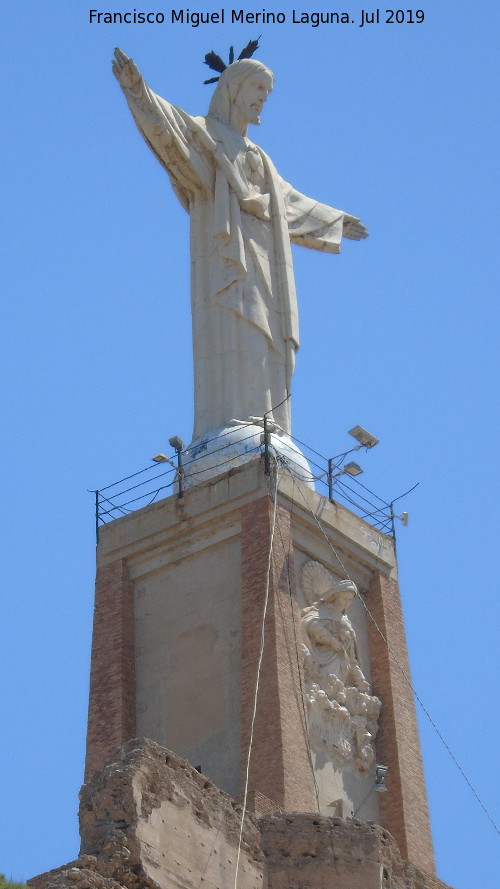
86,462,433,872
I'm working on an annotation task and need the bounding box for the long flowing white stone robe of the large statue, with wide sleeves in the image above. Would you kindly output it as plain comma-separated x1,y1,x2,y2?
124,80,343,439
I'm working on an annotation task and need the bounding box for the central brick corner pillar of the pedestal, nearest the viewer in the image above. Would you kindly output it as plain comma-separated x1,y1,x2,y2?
241,496,316,812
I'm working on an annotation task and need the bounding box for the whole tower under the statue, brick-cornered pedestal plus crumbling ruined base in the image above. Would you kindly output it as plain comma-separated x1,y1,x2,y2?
30,456,454,889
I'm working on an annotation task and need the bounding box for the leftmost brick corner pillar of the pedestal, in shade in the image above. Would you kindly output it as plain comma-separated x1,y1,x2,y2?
85,559,135,781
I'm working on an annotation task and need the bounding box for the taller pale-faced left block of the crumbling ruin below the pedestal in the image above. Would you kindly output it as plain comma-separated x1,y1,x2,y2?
30,739,263,889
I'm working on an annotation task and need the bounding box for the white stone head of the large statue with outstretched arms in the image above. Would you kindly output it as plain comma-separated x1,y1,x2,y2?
208,59,274,126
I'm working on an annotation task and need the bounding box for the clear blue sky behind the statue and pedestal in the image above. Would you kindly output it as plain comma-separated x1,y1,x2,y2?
0,0,500,889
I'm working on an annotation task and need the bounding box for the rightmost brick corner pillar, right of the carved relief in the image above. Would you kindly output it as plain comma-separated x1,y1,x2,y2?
367,572,435,874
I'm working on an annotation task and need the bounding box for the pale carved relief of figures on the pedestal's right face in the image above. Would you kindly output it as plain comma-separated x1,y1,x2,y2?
302,561,381,771
